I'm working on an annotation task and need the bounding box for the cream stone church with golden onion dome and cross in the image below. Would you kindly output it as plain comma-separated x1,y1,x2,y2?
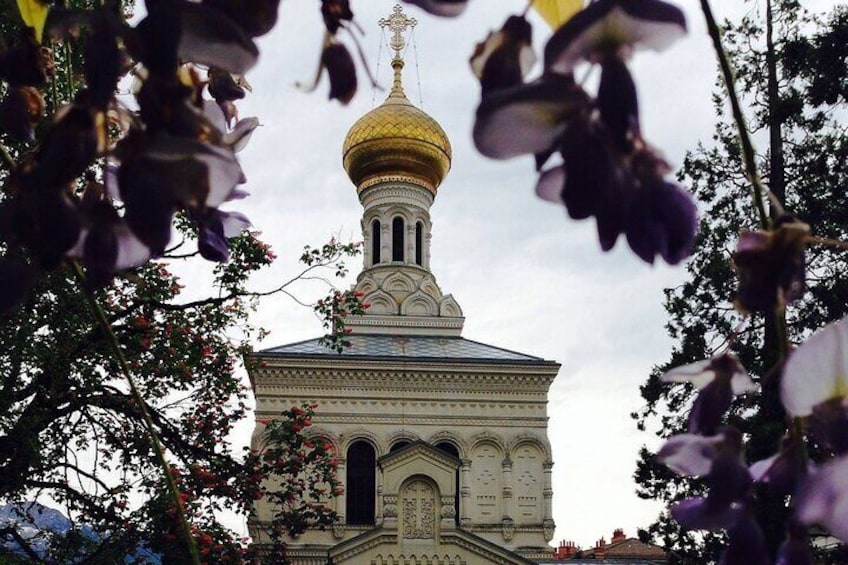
250,7,560,565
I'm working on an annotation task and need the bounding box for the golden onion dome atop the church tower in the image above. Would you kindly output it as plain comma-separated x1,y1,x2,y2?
342,60,451,195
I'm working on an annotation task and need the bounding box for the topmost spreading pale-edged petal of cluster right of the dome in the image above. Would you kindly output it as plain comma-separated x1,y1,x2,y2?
545,0,686,73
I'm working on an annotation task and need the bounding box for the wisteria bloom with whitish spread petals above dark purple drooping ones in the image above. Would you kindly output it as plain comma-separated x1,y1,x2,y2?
660,353,757,434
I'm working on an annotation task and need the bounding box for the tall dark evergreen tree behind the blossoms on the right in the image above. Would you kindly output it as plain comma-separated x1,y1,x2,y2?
634,1,848,563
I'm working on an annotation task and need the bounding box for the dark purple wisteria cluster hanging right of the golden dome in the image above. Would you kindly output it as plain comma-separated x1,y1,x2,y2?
471,0,697,264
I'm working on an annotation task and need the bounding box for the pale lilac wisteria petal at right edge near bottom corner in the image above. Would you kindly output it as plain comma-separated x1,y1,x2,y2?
795,457,848,542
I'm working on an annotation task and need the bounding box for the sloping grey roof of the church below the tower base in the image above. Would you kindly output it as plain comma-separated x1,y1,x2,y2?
258,334,556,365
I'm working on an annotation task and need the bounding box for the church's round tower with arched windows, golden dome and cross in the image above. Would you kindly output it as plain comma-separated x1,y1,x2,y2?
342,6,464,336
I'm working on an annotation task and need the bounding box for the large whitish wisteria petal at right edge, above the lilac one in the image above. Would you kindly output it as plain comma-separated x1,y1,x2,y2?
780,318,848,417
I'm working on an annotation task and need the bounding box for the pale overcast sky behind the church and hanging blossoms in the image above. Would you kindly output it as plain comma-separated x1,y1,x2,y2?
195,0,820,546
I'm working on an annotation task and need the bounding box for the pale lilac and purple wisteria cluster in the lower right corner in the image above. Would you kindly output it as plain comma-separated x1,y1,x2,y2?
658,312,848,563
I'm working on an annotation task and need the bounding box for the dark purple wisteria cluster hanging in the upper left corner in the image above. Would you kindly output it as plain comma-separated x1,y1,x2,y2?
0,0,268,307
